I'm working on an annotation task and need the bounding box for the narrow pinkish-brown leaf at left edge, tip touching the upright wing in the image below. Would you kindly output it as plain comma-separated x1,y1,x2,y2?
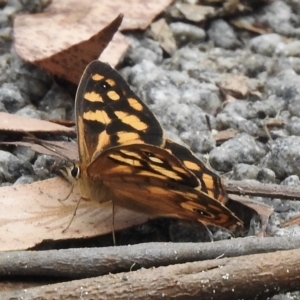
0,112,75,135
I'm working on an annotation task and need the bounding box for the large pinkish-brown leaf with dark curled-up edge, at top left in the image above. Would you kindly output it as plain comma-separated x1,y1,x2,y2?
14,0,172,84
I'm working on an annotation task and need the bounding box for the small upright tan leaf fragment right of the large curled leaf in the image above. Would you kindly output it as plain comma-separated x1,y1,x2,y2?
150,19,177,56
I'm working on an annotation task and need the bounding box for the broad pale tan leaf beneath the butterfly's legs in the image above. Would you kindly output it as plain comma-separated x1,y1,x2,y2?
0,178,149,251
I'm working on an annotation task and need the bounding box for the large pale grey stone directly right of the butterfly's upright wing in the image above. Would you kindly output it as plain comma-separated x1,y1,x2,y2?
133,68,221,152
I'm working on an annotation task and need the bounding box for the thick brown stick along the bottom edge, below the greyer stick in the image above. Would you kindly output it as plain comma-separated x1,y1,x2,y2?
0,249,300,300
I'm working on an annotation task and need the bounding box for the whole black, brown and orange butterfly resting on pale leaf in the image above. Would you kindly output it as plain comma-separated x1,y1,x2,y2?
67,61,242,229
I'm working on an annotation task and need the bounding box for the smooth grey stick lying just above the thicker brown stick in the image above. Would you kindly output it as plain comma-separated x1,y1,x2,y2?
0,237,300,280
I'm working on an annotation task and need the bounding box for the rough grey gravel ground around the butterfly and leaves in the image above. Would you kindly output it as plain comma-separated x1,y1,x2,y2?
0,0,300,300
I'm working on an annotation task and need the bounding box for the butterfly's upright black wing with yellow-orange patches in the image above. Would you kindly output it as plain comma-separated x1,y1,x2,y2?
76,61,164,164
